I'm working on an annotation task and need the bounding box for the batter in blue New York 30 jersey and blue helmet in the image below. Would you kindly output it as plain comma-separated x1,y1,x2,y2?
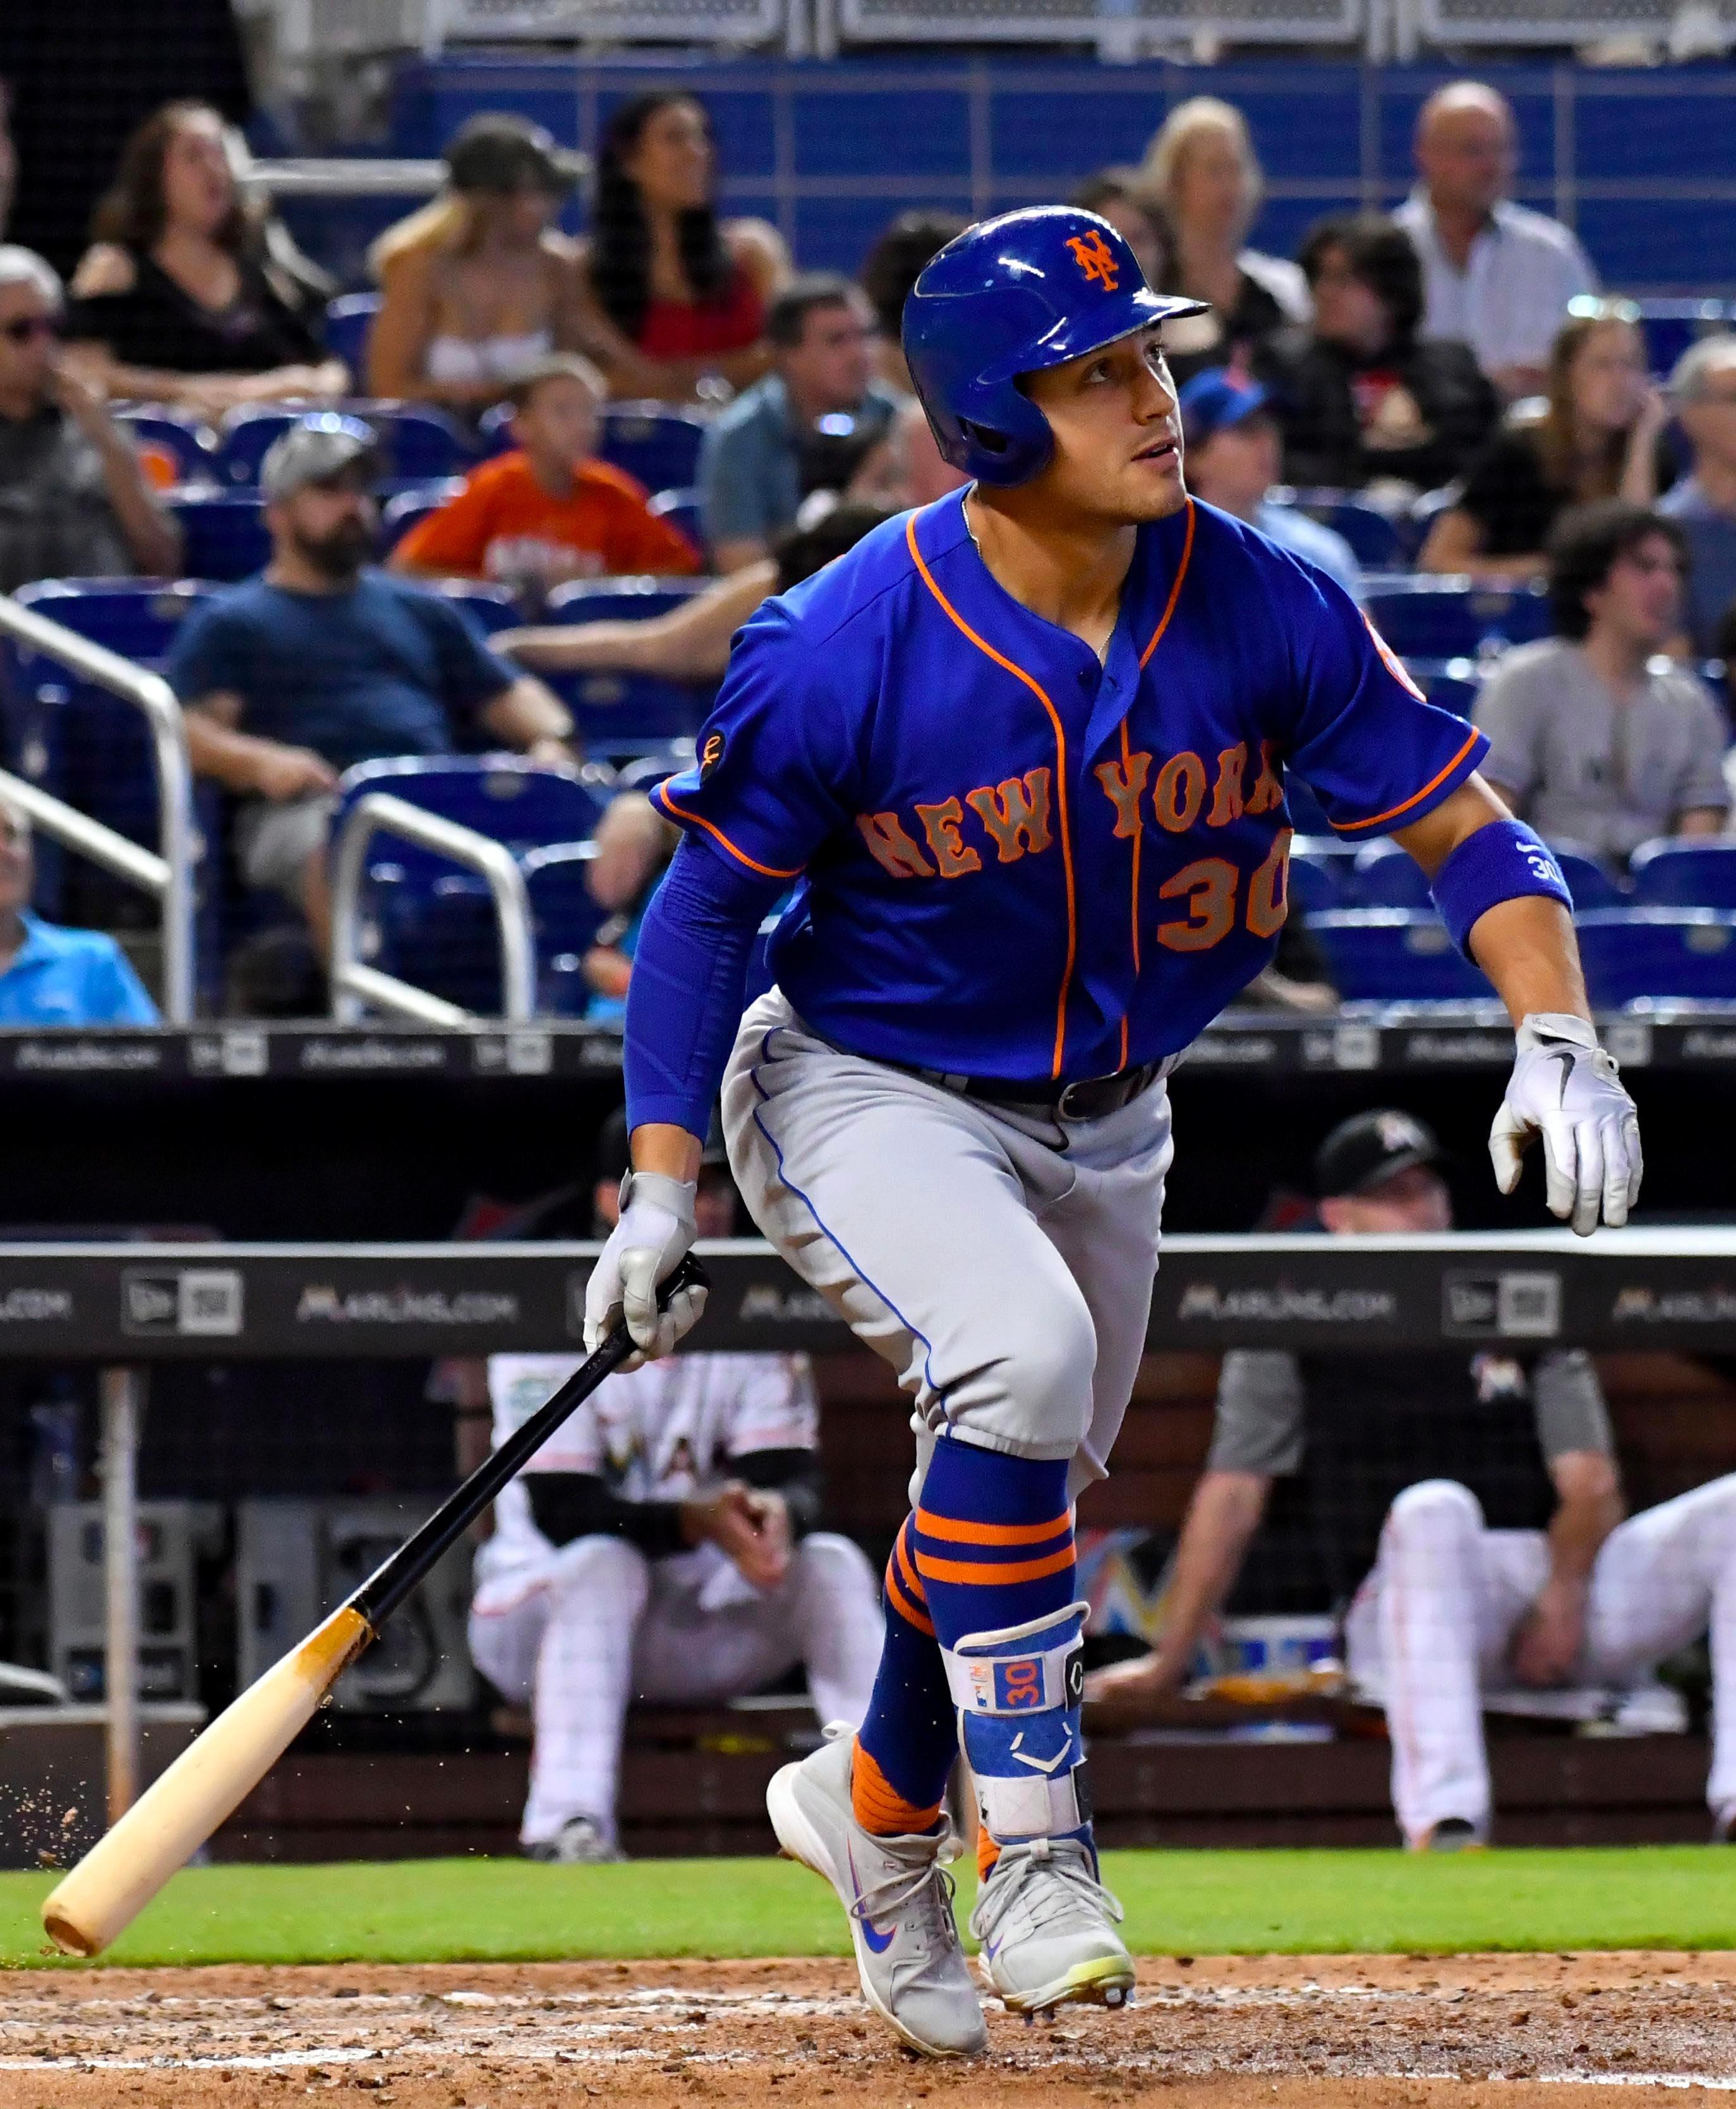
586,207,1639,2057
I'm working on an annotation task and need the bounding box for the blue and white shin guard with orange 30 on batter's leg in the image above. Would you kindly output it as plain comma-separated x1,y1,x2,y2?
941,1603,1090,1843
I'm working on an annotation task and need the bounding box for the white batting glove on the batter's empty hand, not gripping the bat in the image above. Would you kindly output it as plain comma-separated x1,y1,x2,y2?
1489,1010,1645,1238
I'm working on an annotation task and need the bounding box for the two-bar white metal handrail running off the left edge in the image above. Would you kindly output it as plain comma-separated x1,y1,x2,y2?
0,593,196,1025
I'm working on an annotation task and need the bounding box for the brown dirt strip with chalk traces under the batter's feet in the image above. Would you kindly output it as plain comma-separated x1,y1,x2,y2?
0,1953,1736,2109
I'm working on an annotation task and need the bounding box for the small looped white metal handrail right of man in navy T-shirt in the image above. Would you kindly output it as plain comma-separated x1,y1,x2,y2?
331,791,536,1027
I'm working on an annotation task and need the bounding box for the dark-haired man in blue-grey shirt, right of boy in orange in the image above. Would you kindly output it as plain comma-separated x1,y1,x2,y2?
701,272,898,572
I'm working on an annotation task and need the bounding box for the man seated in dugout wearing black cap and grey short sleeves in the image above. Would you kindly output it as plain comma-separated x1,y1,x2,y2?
1087,1109,1736,1852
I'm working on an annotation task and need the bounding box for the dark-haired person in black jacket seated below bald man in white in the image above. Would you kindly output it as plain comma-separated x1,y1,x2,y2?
1259,213,1500,492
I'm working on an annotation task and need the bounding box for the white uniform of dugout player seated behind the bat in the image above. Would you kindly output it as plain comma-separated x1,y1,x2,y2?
471,1354,882,1846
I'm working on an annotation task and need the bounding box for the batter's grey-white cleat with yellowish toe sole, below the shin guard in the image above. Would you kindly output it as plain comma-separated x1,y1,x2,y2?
970,1837,1133,2014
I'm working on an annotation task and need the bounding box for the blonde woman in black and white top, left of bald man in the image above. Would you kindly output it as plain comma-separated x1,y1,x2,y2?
1139,95,1308,382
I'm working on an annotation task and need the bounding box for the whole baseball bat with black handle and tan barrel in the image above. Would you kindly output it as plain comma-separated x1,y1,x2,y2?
42,1255,704,1955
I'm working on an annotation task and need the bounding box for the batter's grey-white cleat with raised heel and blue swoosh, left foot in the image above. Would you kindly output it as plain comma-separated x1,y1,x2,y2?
766,1723,989,2058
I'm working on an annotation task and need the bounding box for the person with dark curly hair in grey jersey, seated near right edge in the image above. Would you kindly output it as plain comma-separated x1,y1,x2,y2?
1473,498,1730,865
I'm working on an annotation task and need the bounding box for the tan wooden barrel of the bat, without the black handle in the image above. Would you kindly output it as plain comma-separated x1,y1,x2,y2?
42,1605,373,1955
